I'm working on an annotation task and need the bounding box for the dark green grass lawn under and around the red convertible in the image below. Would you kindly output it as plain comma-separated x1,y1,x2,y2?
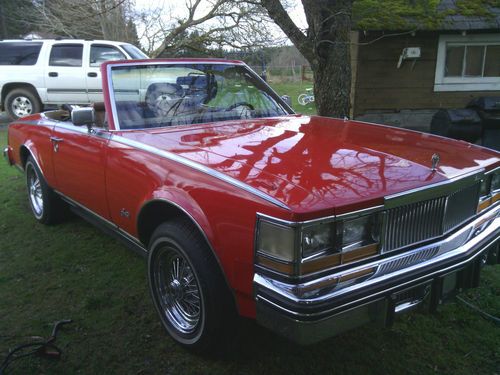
0,127,500,375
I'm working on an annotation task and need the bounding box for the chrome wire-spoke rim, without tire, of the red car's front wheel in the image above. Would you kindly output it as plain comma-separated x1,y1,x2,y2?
153,245,202,335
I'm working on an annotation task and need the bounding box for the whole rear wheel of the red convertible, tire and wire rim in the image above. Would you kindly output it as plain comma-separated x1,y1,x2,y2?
24,156,63,224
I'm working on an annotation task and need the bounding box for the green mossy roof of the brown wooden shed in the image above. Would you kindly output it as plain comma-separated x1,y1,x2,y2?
353,0,500,30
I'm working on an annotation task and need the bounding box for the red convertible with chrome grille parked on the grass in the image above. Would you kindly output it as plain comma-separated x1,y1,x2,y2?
4,59,500,350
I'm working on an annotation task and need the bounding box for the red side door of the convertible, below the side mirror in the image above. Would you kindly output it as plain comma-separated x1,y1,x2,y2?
51,122,110,219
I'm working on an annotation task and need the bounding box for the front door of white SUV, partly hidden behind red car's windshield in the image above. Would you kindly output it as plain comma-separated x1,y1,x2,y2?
85,43,127,103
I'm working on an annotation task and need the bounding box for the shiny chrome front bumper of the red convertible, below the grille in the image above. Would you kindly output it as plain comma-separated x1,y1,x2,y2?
254,204,500,316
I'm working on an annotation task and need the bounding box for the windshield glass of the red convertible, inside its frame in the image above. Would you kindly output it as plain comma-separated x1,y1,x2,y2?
110,63,289,129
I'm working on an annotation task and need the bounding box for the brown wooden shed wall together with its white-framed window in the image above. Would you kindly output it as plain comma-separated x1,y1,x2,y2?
351,0,500,129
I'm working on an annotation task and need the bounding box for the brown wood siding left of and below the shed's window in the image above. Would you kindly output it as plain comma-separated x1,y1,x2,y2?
354,32,500,116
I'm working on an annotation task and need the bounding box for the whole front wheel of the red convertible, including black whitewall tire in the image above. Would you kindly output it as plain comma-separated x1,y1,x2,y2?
148,219,235,353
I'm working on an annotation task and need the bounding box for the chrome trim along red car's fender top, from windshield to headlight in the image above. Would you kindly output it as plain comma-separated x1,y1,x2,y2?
110,134,290,210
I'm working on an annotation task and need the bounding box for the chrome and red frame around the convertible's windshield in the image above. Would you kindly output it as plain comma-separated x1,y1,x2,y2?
101,59,295,132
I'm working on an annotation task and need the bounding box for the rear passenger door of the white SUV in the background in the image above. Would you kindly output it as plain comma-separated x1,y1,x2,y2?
45,42,89,104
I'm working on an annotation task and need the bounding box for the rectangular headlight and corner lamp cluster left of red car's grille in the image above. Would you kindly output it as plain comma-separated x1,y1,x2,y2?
256,212,381,276
